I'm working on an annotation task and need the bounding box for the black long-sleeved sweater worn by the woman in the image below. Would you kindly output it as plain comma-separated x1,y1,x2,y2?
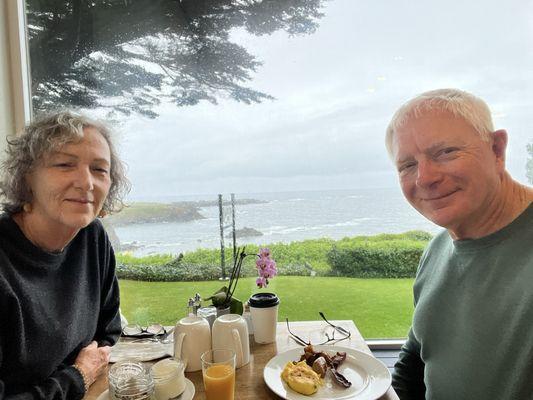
0,215,120,400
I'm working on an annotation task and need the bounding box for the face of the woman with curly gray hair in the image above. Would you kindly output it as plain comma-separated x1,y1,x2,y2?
27,127,111,231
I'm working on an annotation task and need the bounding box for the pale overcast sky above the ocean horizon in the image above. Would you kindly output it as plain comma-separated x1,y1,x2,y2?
113,0,533,200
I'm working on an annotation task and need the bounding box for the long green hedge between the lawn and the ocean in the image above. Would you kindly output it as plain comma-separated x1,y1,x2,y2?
117,231,431,281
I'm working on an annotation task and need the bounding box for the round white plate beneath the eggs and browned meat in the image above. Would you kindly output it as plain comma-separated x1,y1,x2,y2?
263,345,391,400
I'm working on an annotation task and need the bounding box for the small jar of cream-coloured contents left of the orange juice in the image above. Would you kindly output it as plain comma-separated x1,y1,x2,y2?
152,358,185,400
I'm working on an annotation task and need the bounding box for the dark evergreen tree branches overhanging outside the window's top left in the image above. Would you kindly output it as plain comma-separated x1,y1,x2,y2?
26,0,324,118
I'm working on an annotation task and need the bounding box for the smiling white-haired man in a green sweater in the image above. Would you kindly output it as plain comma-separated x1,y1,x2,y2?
386,89,533,400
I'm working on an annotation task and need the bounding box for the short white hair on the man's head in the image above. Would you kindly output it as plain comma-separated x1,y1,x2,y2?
385,89,494,157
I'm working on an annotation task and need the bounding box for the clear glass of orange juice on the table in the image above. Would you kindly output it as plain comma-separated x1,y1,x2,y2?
201,349,235,400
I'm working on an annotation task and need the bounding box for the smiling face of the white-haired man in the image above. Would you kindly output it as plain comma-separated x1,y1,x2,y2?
392,111,504,237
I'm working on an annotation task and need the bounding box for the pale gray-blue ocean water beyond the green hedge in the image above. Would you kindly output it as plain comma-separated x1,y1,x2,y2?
115,188,442,256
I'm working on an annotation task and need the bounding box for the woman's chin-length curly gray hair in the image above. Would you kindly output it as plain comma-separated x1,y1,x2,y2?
0,111,130,214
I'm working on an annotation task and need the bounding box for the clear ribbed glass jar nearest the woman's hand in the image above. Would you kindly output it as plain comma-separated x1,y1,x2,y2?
109,361,155,400
